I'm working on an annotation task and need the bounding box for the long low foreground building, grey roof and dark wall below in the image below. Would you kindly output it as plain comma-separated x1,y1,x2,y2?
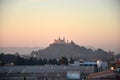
0,66,94,80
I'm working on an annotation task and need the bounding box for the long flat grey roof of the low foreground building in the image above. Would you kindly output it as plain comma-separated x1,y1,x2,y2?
0,66,94,73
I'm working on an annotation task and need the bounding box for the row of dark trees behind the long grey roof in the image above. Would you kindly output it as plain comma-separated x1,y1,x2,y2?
0,53,74,66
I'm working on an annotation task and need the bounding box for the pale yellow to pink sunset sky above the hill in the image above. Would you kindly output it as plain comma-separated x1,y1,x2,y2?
0,0,120,53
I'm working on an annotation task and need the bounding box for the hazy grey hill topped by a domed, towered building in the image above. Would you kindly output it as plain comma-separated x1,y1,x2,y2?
31,39,110,60
